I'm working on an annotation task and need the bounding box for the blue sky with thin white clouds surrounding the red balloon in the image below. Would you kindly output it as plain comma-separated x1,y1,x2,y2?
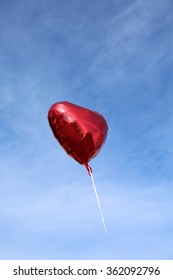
0,0,173,259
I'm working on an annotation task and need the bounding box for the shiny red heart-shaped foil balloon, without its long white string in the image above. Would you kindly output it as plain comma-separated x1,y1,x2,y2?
48,101,108,174
